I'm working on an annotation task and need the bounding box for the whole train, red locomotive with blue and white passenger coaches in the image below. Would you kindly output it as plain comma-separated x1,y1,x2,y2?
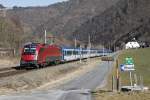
20,43,111,68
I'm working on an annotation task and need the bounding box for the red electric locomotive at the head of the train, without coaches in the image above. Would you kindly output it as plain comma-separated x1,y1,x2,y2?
20,43,62,68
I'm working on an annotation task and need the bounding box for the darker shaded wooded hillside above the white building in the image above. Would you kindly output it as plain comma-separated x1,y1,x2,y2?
74,0,150,46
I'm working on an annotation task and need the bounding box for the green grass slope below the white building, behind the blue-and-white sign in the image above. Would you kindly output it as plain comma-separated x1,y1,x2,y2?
118,48,150,86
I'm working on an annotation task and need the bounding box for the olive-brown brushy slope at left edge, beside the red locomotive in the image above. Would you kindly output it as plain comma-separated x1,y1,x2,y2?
0,10,38,51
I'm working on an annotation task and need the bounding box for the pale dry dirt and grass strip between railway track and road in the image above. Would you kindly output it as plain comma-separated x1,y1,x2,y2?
0,58,100,94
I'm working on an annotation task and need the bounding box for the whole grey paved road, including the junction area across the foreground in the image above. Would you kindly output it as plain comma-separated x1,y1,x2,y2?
0,62,113,100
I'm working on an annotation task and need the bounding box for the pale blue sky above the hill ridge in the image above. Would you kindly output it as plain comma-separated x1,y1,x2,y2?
0,0,68,7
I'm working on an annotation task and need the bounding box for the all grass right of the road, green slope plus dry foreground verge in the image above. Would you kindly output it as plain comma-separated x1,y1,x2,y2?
93,48,150,100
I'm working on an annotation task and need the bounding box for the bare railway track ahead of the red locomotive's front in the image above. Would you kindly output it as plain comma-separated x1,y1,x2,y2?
0,67,27,78
